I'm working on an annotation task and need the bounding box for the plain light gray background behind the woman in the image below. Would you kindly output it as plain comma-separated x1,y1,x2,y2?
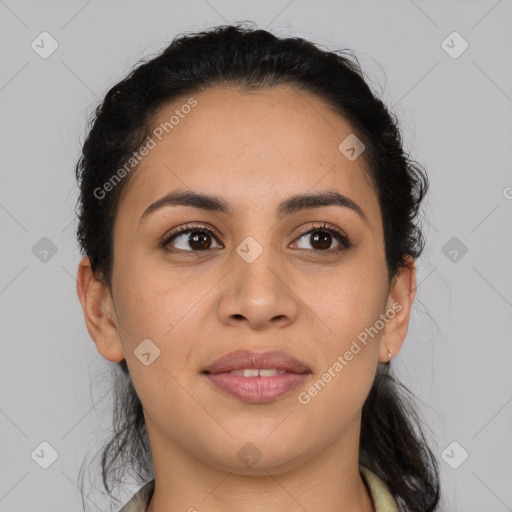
0,0,512,512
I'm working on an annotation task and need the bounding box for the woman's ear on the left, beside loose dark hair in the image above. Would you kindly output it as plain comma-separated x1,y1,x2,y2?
76,256,124,362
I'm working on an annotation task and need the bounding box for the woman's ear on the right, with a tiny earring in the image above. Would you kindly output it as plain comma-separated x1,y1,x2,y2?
379,256,416,363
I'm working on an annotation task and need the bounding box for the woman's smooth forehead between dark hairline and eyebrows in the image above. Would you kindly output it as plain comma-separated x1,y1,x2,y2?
120,86,378,224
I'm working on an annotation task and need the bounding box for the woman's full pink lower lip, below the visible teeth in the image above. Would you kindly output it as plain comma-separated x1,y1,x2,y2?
206,372,309,404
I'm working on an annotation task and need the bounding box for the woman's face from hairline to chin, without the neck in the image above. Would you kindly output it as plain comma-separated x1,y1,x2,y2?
81,86,411,473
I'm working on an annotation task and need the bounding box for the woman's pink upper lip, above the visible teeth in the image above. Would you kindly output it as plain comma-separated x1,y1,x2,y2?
203,350,311,373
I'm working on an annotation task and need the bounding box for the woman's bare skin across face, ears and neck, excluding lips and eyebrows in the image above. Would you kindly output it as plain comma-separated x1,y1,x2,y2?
77,86,415,512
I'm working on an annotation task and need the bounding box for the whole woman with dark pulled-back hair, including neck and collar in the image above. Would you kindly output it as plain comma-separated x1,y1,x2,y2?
76,24,439,512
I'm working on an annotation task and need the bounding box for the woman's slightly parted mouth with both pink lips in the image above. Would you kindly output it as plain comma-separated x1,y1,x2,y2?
202,350,312,404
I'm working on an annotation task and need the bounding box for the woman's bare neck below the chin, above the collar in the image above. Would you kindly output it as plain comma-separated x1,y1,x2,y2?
142,418,375,512
